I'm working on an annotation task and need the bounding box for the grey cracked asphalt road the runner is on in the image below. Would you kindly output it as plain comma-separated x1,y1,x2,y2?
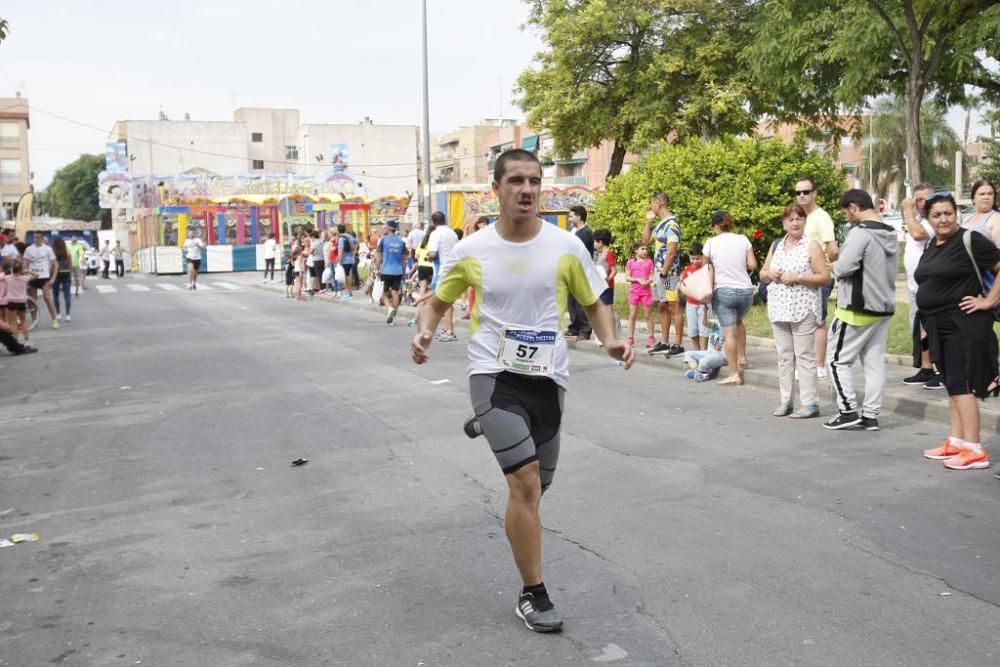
0,277,1000,666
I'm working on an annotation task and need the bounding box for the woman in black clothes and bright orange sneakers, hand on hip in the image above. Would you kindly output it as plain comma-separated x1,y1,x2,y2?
914,192,1000,470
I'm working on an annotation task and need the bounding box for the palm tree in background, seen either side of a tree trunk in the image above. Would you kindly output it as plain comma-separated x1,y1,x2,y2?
859,96,962,197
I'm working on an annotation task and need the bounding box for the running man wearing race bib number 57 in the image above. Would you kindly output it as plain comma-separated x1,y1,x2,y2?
410,149,635,632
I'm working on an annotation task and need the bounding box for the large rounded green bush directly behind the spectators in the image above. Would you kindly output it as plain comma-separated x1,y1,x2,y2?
588,137,845,260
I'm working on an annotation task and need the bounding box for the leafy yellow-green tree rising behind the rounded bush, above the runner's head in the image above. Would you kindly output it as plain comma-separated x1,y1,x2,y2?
517,0,755,176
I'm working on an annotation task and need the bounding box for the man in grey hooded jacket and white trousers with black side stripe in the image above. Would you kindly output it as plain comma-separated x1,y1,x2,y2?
823,190,899,431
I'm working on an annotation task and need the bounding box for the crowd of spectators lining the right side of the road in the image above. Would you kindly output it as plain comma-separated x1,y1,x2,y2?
274,177,1000,480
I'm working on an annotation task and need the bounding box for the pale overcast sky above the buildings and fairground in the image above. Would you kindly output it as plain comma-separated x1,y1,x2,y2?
0,0,540,188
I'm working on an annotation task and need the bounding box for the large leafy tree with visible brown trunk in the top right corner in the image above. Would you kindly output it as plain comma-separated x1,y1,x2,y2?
743,0,1000,188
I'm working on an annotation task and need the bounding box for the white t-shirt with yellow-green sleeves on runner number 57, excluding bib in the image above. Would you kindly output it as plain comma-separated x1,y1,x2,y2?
435,222,607,388
